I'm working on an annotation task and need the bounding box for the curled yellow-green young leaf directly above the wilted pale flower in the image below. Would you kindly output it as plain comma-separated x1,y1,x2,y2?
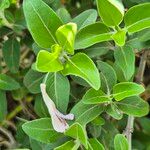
36,45,63,72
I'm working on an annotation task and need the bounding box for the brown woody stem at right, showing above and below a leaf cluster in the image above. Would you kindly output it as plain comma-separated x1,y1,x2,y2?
124,50,149,150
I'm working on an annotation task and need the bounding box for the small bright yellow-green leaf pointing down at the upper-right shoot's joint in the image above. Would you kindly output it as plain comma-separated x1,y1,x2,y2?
112,30,126,46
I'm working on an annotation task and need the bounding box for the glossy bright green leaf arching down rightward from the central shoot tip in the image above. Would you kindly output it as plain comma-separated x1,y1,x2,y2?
62,53,100,90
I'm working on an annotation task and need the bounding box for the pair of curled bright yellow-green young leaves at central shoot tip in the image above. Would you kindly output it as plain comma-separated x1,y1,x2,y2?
36,23,77,72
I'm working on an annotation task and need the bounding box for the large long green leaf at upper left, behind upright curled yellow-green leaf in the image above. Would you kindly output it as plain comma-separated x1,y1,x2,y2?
23,0,62,48
